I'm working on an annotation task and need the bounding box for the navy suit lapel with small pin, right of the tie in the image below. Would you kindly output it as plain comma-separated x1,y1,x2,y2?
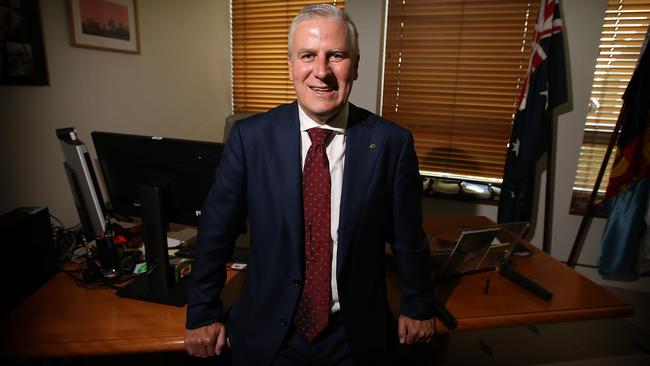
336,104,384,275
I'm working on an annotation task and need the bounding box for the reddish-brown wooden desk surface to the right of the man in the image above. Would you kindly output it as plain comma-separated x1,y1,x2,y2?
388,216,633,332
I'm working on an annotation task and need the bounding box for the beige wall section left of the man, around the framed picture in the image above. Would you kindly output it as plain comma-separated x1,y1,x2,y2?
0,0,231,226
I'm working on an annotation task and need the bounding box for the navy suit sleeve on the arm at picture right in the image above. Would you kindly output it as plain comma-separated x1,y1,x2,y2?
392,132,434,320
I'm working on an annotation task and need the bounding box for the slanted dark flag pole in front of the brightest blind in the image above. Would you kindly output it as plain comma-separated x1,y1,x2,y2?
567,103,627,268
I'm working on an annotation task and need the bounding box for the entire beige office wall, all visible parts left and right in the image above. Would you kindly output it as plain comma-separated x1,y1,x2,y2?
0,0,650,291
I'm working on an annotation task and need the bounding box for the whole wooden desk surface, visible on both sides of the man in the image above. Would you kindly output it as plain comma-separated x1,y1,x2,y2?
0,217,632,357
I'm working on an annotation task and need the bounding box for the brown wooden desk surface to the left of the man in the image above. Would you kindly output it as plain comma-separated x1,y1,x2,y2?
0,270,243,357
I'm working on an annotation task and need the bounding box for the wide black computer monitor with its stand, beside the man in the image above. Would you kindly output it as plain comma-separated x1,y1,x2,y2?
92,131,223,306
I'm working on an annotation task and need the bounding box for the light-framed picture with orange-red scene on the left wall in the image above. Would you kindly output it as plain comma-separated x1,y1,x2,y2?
68,0,140,53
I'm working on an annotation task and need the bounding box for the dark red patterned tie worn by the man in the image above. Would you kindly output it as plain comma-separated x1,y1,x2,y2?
294,128,332,341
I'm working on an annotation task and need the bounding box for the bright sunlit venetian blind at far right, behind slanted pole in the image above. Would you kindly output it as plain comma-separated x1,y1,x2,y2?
571,0,650,213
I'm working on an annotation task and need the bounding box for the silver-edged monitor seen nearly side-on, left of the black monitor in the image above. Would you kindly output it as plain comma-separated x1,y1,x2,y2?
56,127,106,242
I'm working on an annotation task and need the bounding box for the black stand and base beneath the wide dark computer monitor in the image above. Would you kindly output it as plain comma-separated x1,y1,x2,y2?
117,186,188,306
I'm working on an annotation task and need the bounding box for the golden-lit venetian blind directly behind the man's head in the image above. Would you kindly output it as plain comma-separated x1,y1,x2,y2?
230,0,345,113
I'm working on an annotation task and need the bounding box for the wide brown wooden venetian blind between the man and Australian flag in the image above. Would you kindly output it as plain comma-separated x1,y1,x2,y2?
382,0,539,181
